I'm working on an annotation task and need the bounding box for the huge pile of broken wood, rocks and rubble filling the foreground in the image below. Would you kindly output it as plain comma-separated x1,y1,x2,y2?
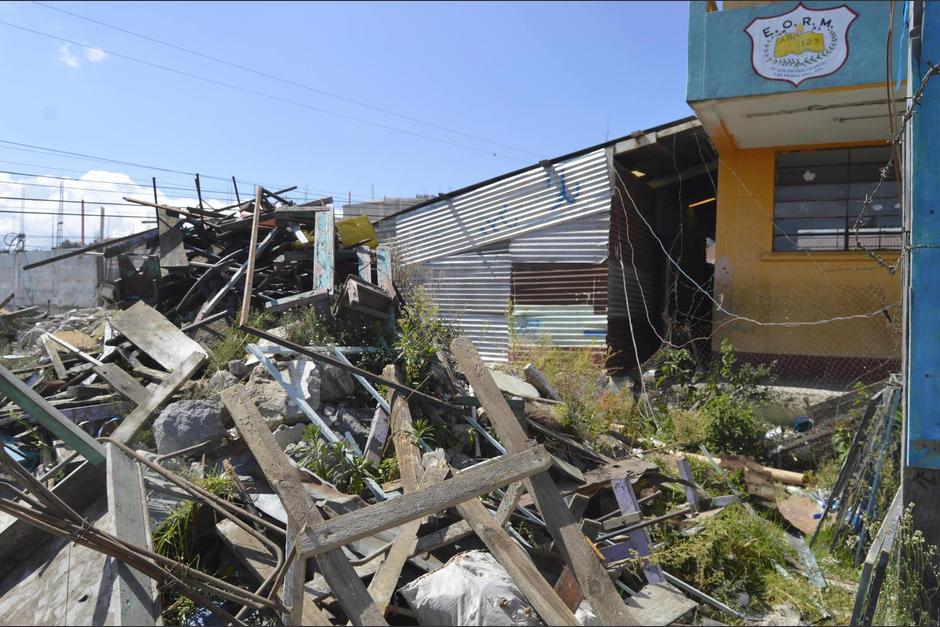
0,188,900,625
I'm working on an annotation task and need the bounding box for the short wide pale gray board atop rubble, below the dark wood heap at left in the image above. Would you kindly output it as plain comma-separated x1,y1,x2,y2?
111,301,207,370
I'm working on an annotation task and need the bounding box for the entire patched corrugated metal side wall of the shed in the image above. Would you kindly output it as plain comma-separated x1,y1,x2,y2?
379,149,610,362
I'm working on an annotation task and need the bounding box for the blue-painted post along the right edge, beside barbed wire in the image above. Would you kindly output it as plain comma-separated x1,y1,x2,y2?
902,0,940,608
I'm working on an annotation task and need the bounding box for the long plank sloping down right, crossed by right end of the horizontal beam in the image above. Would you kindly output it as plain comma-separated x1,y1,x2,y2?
451,337,636,625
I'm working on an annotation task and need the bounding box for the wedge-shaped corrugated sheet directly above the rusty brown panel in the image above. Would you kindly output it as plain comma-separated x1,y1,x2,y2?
509,211,610,263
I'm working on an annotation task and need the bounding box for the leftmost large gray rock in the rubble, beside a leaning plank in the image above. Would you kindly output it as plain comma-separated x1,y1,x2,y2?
153,400,225,455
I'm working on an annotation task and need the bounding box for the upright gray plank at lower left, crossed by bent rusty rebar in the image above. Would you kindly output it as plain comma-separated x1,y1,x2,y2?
105,442,160,625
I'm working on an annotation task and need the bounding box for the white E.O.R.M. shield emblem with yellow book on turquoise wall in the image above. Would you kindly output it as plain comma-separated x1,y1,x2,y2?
744,3,858,87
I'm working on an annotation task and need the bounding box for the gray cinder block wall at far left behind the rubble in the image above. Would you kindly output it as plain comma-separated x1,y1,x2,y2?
0,250,100,309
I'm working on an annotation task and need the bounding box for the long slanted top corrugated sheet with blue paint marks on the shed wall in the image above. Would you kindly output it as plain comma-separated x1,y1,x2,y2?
394,149,611,263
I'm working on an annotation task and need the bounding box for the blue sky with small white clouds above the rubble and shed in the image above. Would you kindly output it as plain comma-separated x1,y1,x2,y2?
0,2,690,247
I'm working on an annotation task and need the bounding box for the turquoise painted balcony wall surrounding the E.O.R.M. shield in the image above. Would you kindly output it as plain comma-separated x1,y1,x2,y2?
686,0,906,102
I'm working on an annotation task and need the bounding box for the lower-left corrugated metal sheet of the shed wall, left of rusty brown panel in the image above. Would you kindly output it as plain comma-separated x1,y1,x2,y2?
415,244,512,362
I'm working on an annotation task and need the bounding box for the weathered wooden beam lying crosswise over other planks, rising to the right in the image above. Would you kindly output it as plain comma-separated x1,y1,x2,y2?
298,446,552,556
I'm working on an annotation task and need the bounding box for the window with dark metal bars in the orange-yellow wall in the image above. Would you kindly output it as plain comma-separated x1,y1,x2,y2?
773,146,901,252
